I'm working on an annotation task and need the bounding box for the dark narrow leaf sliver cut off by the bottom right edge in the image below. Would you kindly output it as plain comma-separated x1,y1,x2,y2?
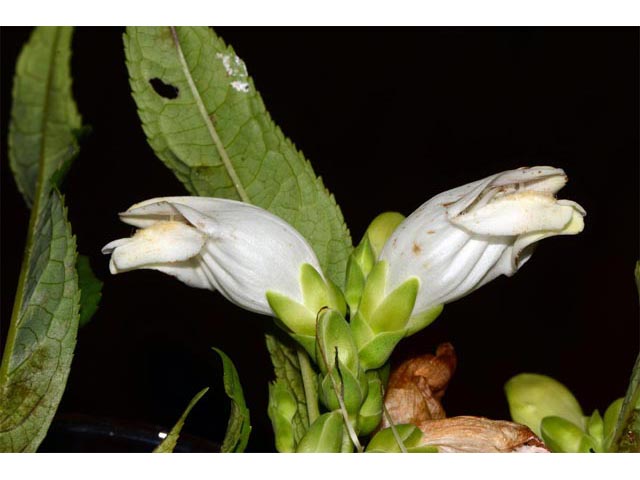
610,355,640,452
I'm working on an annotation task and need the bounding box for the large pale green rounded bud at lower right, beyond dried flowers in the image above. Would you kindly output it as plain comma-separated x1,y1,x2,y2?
504,373,586,436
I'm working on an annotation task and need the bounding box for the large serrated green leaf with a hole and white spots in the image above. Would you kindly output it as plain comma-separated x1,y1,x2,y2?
124,27,352,285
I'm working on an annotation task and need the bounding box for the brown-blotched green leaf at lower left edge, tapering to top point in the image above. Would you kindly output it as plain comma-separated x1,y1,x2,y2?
0,191,80,452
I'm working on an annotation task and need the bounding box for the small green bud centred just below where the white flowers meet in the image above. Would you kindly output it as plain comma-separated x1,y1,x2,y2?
316,308,359,373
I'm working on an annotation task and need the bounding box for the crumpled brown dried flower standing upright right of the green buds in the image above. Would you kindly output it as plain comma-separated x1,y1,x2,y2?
380,343,457,428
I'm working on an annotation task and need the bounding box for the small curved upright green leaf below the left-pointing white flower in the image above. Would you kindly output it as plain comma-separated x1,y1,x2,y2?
213,347,251,453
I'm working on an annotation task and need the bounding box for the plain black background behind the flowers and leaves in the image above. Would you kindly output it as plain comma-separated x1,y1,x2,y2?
1,28,639,451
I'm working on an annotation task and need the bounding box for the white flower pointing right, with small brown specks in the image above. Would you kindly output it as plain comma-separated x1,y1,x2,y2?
379,167,585,315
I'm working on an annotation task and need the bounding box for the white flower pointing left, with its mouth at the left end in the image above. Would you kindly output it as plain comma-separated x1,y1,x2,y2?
102,197,322,315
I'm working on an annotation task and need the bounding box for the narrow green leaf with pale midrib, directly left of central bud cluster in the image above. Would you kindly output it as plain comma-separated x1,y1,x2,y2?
266,334,317,448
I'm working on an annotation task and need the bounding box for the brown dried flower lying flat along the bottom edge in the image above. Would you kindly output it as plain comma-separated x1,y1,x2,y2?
417,416,549,453
